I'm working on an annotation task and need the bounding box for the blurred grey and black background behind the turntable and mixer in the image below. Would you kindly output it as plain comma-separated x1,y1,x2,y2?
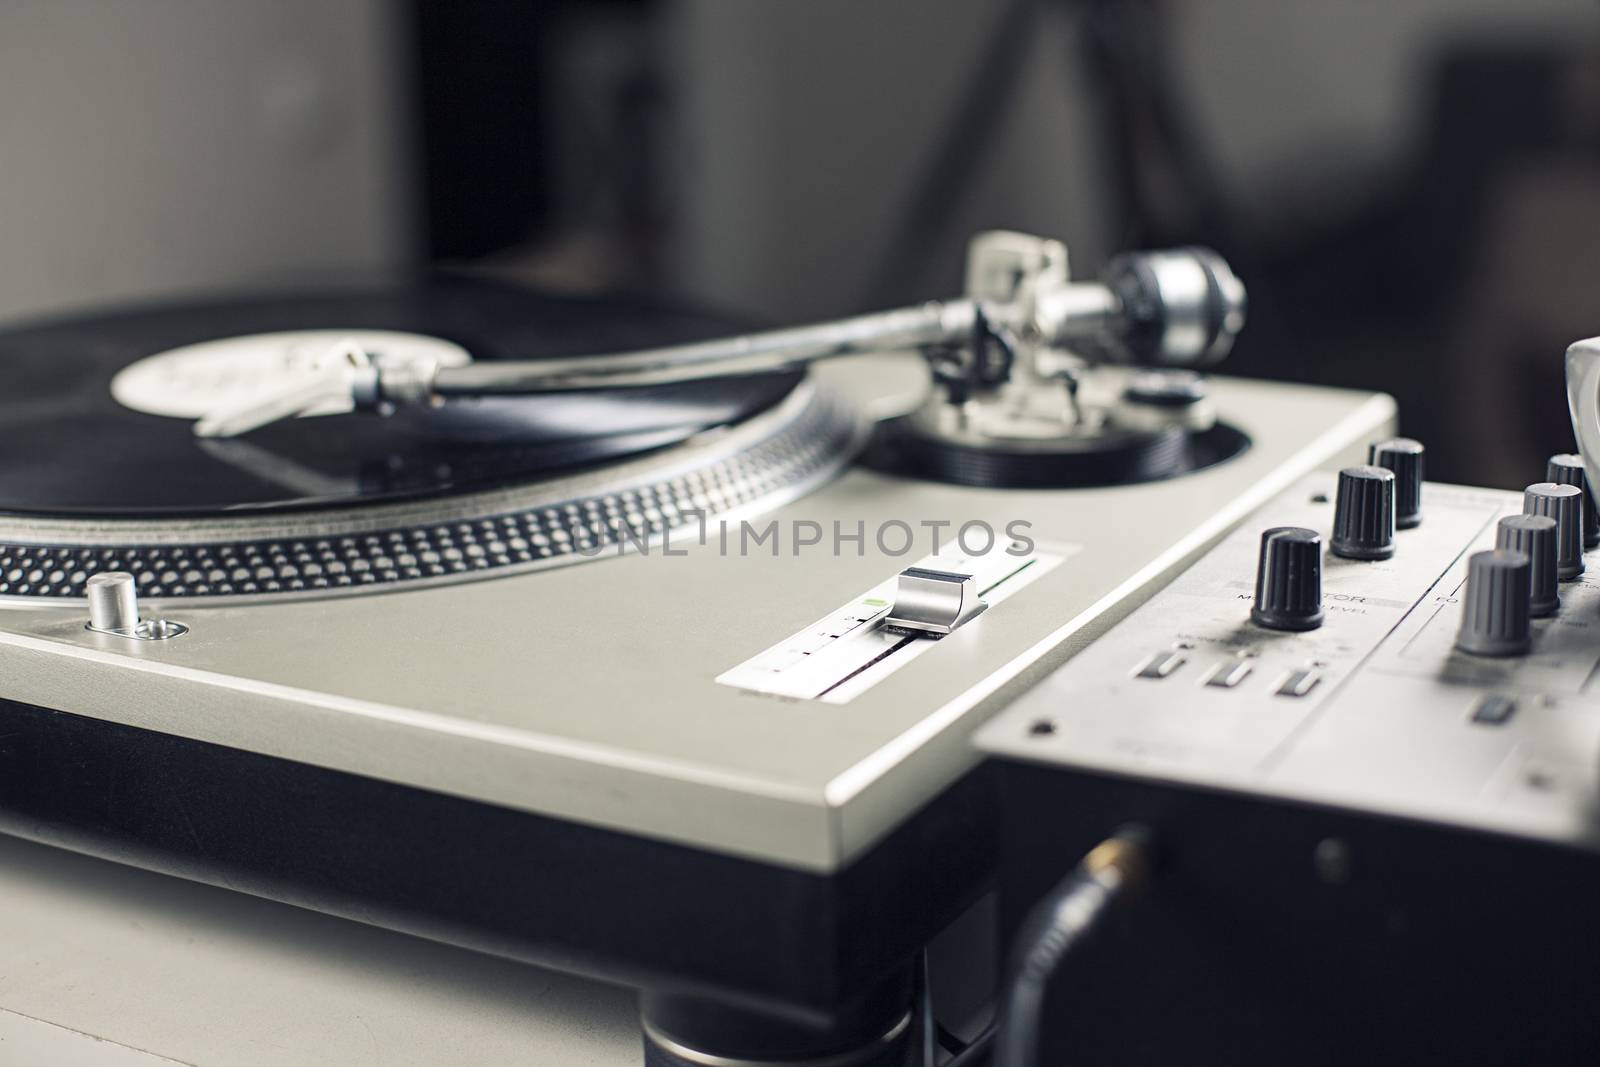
0,0,1600,488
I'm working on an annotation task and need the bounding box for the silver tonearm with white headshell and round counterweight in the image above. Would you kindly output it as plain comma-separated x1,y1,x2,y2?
194,232,1245,437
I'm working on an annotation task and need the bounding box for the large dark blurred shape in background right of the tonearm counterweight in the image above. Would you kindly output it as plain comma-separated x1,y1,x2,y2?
1203,35,1600,488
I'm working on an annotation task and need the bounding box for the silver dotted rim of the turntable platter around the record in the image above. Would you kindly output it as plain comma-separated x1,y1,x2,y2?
0,386,864,600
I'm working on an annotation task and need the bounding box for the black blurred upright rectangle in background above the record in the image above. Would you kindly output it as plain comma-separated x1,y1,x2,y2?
413,0,669,291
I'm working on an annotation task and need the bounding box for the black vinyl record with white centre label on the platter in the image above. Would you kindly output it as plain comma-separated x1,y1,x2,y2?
0,277,798,517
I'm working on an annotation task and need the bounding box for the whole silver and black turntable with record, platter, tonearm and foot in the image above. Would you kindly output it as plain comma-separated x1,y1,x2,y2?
0,234,1394,1064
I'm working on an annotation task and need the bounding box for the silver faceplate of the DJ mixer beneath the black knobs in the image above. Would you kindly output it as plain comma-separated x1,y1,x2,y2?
978,475,1600,848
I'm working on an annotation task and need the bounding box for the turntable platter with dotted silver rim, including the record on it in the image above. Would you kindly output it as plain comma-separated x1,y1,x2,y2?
0,278,866,603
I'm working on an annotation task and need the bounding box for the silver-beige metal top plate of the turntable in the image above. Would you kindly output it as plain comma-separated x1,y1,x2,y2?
0,357,1388,870
